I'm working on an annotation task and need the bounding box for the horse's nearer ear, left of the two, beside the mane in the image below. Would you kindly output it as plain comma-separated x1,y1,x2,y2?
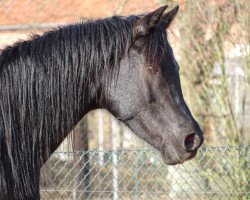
133,5,168,39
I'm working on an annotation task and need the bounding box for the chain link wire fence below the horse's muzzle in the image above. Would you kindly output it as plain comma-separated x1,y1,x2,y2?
40,145,250,200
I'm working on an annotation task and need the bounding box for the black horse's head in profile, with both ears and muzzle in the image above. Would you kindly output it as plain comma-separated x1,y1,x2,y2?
104,6,203,165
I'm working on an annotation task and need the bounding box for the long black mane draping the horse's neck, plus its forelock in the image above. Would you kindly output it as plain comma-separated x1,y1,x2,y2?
0,16,167,199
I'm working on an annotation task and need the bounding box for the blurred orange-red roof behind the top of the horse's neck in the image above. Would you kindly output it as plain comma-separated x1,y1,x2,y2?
0,0,160,25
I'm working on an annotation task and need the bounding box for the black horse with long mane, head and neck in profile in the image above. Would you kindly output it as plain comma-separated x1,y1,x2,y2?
0,6,203,200
